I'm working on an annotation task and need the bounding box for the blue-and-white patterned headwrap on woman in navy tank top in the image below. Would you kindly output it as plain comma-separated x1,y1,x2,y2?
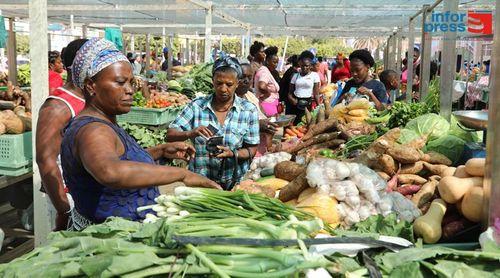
71,38,128,89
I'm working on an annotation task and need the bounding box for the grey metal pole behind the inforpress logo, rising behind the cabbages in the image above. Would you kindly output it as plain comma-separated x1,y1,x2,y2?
439,0,458,121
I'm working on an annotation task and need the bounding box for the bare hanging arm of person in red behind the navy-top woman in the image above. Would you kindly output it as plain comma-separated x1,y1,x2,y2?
36,99,71,231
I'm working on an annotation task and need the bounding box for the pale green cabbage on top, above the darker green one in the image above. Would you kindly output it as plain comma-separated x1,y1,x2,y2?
405,113,450,141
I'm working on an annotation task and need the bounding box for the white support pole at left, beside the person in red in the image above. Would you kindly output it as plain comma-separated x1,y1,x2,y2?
29,0,50,246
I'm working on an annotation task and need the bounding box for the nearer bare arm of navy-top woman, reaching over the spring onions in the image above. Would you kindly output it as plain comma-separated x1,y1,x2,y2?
75,123,220,189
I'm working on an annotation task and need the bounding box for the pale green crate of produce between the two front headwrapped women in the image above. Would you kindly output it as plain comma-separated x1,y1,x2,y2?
117,107,184,125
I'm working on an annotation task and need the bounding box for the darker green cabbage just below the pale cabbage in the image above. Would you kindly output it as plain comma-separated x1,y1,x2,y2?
423,135,465,165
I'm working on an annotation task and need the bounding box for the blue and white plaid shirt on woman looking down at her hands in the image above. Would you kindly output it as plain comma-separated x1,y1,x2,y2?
170,95,260,189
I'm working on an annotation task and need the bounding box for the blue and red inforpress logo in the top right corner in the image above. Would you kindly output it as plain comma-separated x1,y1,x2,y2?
424,10,493,35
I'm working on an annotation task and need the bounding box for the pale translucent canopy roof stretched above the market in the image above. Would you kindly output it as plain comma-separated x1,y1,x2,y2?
0,0,495,37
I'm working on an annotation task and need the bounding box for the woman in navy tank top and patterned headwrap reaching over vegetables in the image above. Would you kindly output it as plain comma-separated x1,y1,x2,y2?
61,39,220,230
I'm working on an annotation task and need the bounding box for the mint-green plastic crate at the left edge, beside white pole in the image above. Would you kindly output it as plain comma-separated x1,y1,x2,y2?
0,131,33,169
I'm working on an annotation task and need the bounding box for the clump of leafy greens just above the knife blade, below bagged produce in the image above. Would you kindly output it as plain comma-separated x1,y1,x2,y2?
344,213,415,242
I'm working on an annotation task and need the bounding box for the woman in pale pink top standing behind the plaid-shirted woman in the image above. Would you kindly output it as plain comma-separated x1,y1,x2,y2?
254,47,280,117
